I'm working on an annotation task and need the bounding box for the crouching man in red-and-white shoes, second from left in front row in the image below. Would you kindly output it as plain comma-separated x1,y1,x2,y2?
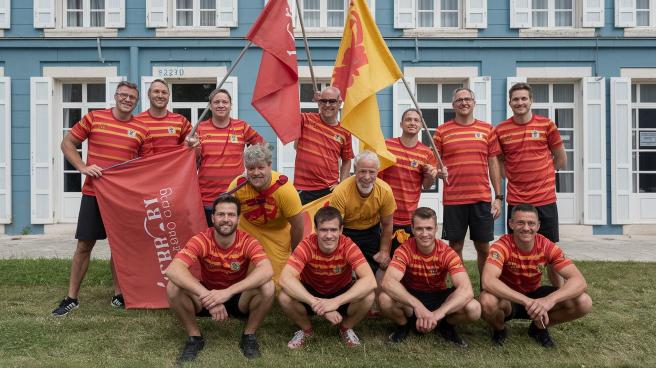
278,207,376,349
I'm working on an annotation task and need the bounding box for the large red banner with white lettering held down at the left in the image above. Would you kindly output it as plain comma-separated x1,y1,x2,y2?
93,147,207,308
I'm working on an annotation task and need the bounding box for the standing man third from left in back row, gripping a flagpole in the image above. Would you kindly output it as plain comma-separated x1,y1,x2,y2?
196,89,264,226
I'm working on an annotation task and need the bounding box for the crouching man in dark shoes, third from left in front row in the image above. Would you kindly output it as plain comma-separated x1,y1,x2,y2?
378,207,481,347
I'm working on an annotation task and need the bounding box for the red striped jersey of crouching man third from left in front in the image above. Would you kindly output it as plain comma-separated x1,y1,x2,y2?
390,238,466,292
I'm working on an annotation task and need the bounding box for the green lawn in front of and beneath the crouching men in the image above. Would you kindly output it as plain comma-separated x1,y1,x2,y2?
0,260,656,368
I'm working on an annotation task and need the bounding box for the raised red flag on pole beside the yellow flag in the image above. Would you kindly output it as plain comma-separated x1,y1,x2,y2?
246,0,301,144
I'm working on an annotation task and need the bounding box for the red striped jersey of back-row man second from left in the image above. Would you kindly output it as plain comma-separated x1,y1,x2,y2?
135,110,191,153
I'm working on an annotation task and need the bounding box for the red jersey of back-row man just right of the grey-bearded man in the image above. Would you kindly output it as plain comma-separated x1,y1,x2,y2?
378,138,437,225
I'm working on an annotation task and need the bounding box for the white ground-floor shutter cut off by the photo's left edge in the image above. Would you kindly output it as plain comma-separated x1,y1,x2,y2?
0,77,11,224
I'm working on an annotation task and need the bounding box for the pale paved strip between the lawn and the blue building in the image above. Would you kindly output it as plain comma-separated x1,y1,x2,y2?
0,232,656,262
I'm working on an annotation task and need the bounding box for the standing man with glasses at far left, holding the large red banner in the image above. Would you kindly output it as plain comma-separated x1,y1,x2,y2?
52,82,152,316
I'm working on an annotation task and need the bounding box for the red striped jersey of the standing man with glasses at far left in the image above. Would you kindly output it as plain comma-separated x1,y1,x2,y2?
70,109,152,196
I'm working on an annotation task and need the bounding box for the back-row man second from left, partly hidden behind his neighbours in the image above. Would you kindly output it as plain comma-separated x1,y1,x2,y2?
135,79,198,153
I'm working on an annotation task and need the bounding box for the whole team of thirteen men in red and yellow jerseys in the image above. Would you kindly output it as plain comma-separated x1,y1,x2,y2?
52,80,592,362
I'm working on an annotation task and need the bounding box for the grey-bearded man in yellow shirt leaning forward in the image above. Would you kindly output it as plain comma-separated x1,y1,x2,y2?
330,151,396,273
